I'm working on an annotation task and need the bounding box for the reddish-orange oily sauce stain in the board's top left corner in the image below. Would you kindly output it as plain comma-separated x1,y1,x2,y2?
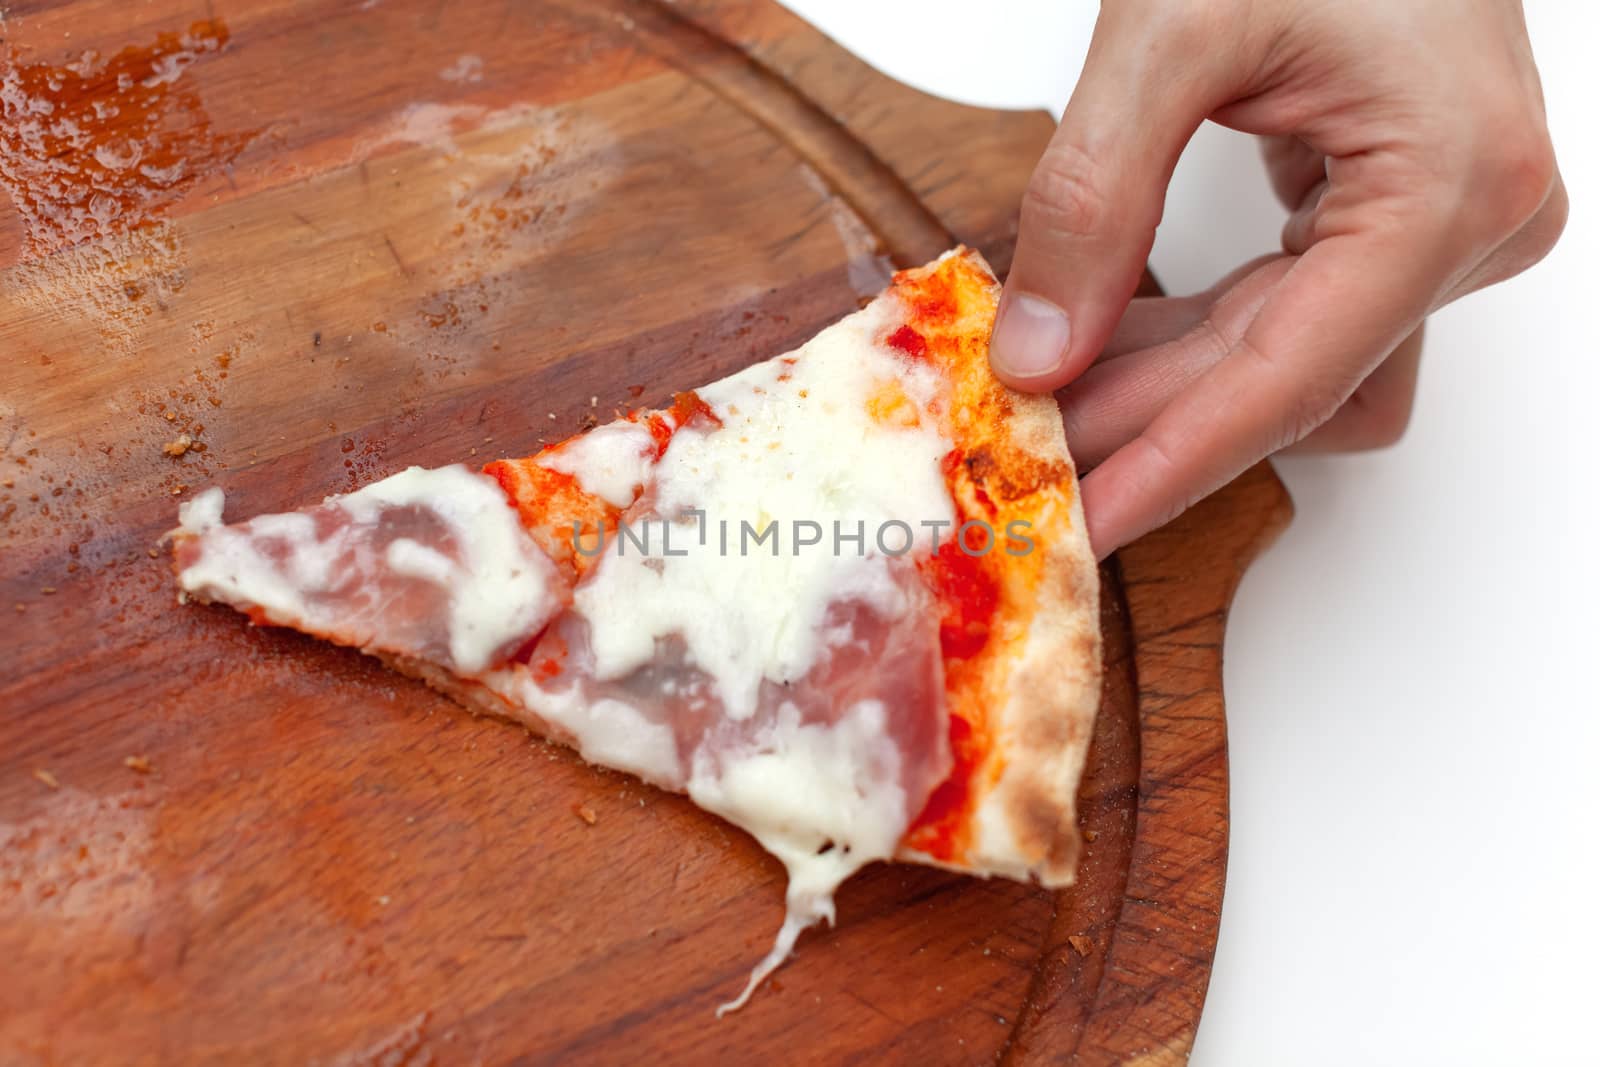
0,19,253,254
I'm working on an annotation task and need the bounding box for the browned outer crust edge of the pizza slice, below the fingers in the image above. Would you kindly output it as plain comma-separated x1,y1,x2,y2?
896,248,1101,886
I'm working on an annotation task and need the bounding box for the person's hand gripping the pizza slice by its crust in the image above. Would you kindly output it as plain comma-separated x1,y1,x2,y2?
990,0,1566,557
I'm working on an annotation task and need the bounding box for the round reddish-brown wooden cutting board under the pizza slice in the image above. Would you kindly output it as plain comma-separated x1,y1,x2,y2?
0,0,1290,1064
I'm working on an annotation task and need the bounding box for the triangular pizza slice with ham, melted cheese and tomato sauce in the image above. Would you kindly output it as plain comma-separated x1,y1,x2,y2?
173,250,1099,1008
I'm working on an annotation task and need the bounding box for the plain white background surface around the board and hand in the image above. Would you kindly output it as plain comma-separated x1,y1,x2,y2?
786,0,1600,1067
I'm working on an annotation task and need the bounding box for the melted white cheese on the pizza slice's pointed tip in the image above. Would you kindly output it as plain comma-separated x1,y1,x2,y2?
178,466,560,675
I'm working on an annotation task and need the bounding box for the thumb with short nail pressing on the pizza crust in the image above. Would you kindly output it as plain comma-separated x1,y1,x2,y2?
989,5,1214,392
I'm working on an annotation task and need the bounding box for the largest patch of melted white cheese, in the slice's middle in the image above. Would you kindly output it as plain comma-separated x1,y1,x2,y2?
574,295,954,718
